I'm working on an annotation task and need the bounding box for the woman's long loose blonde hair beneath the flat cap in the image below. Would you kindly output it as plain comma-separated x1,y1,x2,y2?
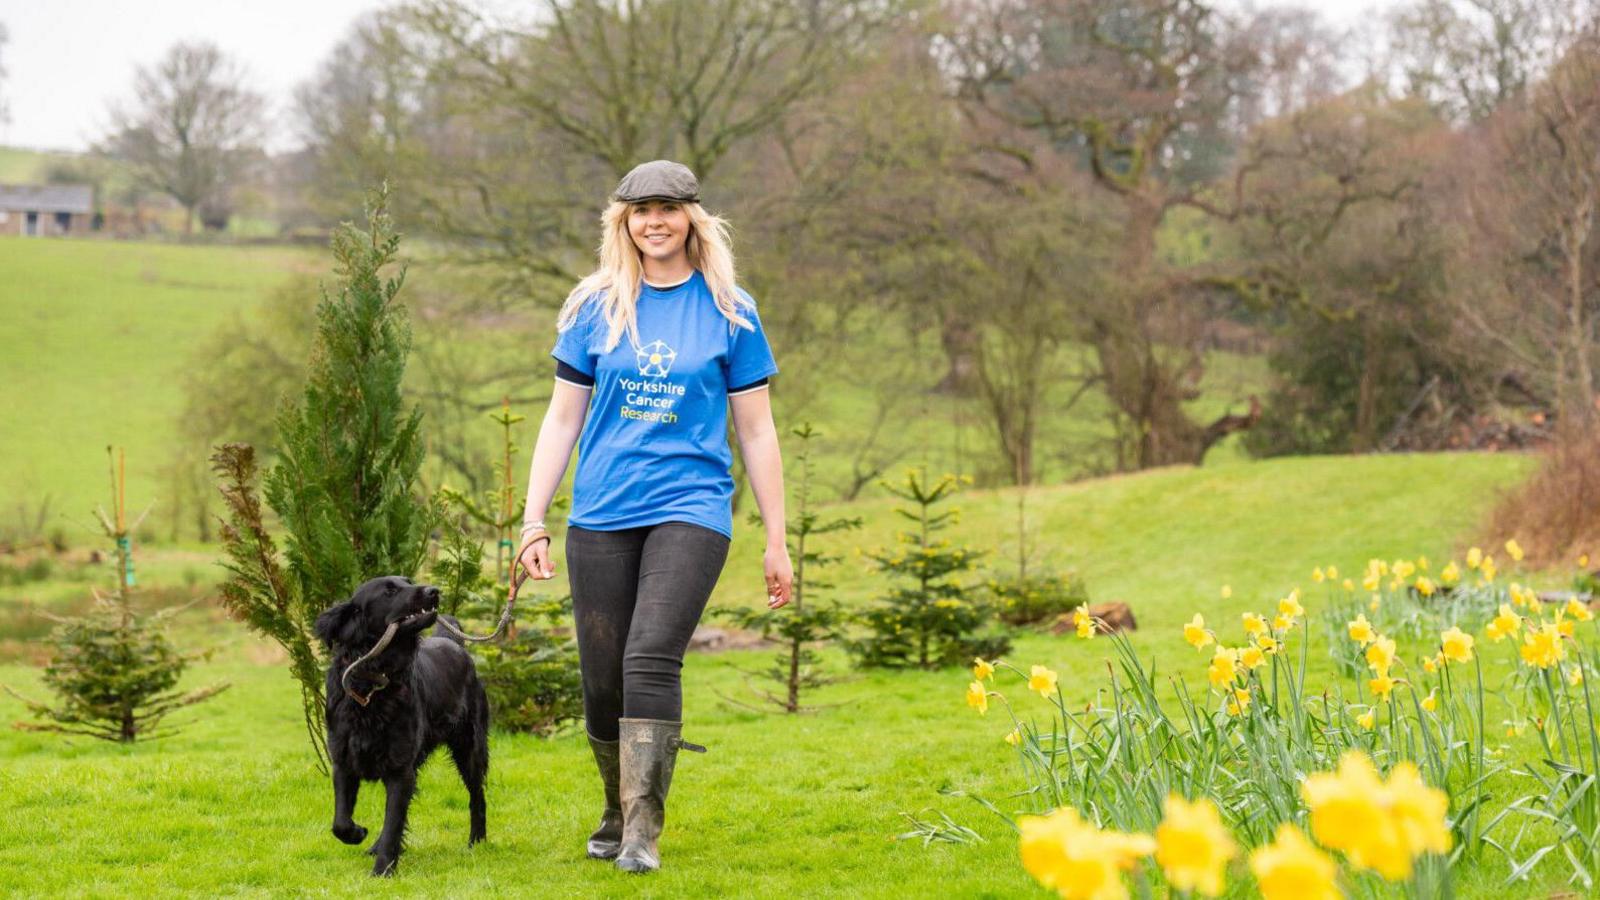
555,200,755,352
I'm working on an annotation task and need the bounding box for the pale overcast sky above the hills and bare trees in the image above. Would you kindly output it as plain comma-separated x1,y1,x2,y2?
0,0,1398,151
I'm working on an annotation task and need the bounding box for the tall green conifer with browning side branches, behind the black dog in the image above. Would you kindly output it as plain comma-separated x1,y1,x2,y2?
213,187,440,759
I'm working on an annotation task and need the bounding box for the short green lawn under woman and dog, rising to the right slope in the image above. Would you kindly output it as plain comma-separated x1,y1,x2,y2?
0,455,1560,897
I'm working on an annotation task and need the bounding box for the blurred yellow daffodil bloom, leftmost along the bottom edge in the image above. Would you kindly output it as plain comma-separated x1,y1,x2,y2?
1016,807,1155,900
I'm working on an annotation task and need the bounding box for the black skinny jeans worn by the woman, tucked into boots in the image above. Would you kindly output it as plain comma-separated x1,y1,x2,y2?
566,522,728,740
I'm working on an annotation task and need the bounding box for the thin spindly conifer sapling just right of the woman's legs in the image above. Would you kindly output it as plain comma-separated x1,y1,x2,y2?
718,423,861,713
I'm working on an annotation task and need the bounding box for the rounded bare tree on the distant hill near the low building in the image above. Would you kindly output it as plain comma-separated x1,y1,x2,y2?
101,43,266,234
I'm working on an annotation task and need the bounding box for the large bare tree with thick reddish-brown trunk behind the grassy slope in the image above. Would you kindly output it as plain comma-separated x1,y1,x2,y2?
939,0,1256,468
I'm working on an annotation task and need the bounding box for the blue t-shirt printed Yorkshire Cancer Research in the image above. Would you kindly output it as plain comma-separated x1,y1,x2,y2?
550,271,778,538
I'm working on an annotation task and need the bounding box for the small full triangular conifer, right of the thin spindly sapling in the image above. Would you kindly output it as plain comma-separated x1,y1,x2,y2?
850,469,1010,669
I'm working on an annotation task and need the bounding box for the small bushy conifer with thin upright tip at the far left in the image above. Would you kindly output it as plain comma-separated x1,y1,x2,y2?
6,447,227,743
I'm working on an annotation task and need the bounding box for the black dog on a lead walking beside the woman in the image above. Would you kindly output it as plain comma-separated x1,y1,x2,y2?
317,577,490,874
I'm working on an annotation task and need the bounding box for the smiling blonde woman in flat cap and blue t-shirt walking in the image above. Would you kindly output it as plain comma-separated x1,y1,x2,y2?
517,160,794,871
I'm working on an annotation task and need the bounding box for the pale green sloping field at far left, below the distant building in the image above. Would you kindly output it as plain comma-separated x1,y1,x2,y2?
0,237,312,536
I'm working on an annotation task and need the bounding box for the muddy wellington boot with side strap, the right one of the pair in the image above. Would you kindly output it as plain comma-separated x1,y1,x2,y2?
616,719,706,871
